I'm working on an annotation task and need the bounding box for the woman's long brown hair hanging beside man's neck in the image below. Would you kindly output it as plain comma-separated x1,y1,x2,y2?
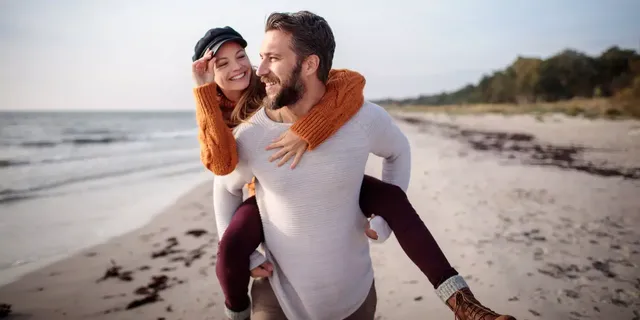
227,68,267,127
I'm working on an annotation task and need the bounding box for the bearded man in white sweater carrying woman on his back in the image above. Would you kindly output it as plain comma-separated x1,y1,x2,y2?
214,12,512,320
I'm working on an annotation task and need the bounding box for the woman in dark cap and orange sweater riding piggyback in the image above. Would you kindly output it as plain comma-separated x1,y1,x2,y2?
192,27,512,320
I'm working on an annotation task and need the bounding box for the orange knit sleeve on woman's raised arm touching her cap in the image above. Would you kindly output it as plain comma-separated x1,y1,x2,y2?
193,83,238,175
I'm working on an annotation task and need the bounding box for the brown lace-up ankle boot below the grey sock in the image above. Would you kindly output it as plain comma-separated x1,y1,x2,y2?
447,288,516,320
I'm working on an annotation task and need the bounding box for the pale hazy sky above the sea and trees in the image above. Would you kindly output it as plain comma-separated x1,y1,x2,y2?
0,0,640,110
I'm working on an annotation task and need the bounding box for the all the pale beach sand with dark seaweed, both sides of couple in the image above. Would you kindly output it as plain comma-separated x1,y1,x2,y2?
0,113,640,320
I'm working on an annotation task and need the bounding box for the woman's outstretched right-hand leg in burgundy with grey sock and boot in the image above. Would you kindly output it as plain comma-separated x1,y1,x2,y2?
360,176,514,320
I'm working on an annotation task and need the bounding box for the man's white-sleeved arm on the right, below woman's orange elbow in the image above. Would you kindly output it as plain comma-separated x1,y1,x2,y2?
368,103,411,192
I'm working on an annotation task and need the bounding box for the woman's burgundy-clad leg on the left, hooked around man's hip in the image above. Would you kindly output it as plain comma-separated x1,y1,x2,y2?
216,196,264,319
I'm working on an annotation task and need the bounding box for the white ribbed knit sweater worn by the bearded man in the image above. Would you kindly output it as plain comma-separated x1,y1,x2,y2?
214,102,411,320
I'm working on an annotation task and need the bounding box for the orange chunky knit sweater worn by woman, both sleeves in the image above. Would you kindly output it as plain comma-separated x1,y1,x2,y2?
193,69,365,175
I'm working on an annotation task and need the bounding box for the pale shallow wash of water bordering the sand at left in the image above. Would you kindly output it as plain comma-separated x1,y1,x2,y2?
0,173,206,286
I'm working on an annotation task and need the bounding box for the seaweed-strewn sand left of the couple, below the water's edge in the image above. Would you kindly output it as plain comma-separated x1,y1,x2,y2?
0,182,229,319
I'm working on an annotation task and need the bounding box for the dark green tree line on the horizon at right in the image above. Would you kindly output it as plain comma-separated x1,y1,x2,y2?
376,46,640,109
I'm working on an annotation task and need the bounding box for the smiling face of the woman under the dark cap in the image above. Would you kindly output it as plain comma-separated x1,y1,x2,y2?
214,41,253,91
